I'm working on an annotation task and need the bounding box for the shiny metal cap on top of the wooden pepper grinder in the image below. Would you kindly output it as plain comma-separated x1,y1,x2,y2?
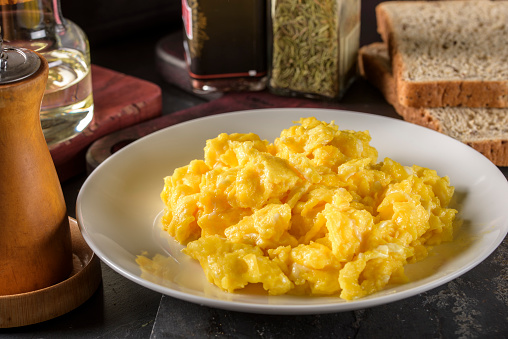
0,44,41,85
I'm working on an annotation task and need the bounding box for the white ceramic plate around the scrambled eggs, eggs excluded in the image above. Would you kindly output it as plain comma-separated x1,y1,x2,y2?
77,109,508,314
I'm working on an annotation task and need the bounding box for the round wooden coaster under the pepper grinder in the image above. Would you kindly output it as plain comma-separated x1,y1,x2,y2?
0,218,102,328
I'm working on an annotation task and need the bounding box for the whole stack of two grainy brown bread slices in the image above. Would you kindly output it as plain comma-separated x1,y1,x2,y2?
359,0,508,166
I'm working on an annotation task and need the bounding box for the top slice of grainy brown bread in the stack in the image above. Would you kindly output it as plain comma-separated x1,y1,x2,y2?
376,0,508,107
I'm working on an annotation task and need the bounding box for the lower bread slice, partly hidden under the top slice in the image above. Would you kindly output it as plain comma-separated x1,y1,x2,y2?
358,43,508,166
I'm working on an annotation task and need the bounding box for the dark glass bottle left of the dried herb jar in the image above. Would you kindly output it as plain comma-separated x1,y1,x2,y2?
182,0,268,93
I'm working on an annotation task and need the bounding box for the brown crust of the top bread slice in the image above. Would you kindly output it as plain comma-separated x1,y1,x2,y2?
376,1,508,108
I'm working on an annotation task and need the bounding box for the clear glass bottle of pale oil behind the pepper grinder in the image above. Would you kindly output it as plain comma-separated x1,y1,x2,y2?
0,0,94,145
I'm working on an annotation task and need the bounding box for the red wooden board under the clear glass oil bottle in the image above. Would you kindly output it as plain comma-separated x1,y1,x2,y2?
50,65,162,182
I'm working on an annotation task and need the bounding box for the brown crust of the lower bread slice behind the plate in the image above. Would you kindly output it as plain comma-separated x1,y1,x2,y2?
358,43,508,166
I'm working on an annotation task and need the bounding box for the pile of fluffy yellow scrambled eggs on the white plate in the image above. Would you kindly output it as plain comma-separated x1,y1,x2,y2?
148,118,457,300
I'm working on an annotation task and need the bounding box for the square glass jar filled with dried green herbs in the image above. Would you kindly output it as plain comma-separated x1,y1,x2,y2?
269,0,361,99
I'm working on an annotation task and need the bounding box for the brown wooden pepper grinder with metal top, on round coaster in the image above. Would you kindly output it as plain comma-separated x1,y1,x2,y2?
0,36,73,296
